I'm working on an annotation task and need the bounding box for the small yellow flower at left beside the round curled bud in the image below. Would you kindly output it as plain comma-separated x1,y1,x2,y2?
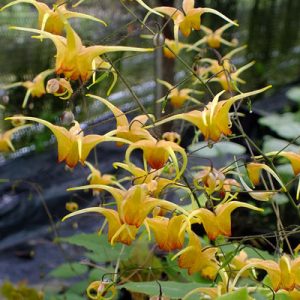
3,70,54,108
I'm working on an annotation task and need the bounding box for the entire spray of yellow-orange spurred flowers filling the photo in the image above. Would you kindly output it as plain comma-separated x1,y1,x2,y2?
0,0,300,299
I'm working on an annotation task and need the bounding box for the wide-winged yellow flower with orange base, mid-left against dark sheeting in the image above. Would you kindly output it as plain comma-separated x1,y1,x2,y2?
7,116,129,168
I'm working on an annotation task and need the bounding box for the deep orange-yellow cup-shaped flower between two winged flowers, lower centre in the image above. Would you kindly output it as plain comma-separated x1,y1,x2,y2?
146,215,186,251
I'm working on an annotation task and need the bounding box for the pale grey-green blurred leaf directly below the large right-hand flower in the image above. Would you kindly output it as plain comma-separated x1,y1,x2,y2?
188,142,246,158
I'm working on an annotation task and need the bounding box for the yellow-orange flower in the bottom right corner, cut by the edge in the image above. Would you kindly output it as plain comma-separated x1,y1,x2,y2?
244,255,300,292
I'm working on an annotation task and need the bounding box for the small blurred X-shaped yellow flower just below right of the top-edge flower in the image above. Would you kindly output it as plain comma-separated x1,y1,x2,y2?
191,23,237,49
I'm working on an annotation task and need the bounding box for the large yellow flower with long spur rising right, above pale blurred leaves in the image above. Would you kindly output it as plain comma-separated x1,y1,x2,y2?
155,86,271,142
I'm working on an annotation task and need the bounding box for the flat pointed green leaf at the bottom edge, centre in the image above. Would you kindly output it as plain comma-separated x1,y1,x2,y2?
120,281,211,300
